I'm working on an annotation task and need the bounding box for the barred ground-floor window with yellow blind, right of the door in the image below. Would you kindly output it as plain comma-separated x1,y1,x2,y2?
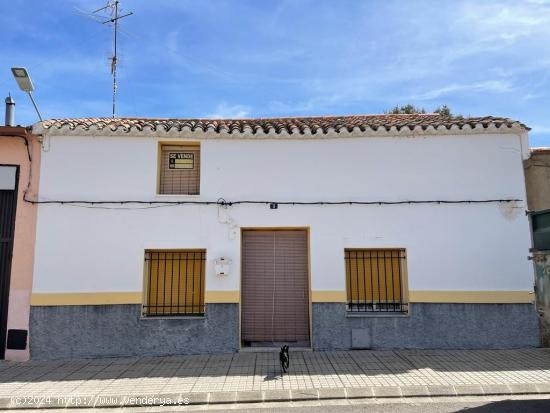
345,249,407,313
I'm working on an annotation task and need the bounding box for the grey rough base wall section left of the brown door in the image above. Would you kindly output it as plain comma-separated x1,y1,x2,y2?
29,304,239,360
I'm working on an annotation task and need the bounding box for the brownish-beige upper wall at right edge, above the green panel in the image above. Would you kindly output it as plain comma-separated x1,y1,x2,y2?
524,148,550,211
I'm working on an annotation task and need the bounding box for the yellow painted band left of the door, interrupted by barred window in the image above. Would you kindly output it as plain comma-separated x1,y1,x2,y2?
31,291,239,306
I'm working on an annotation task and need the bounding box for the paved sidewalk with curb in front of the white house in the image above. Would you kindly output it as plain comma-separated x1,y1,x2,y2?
0,349,550,409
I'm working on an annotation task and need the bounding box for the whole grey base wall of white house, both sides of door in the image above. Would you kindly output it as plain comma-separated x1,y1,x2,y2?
29,303,540,360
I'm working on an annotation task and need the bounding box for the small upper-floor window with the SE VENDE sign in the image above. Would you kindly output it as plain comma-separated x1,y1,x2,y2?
159,145,201,195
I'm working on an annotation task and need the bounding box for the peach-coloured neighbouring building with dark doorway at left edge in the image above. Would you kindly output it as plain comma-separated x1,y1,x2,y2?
0,126,40,360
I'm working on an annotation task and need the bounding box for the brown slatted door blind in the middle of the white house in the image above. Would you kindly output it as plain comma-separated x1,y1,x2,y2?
241,230,309,346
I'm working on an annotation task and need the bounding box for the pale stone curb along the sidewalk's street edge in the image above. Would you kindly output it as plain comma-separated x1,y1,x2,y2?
0,383,550,410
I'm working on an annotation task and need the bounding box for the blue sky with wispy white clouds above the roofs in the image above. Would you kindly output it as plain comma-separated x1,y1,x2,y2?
0,0,550,146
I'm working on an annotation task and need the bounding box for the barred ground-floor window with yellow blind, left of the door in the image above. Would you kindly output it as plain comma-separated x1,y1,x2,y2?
143,250,206,316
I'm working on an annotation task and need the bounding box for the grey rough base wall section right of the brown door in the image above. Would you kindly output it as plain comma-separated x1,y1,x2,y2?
312,303,539,350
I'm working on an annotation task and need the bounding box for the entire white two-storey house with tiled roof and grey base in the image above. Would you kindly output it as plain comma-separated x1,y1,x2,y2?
31,115,539,358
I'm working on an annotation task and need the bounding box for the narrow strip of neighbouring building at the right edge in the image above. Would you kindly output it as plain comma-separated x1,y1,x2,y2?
524,148,550,347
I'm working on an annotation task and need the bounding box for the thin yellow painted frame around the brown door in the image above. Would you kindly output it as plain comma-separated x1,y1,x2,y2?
239,226,313,350
